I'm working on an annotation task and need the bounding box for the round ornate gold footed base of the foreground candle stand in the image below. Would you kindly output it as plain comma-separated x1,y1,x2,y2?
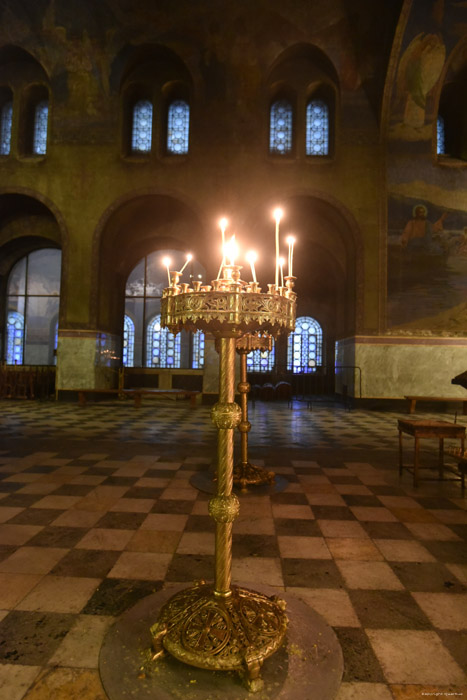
151,581,287,692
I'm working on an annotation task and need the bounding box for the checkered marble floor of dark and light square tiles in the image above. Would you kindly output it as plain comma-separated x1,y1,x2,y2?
0,400,467,700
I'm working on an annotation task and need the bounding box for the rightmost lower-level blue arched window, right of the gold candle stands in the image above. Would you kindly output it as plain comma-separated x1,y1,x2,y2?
287,316,323,374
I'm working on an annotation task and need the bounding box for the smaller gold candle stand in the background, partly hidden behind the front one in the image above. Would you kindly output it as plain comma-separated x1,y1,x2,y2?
233,331,276,491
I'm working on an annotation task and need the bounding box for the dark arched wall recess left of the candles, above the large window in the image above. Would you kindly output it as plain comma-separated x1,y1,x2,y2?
93,194,212,333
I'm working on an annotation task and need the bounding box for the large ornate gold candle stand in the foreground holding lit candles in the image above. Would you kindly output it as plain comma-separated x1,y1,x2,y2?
151,265,296,692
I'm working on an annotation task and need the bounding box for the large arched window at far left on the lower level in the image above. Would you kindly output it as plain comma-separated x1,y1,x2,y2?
4,248,61,365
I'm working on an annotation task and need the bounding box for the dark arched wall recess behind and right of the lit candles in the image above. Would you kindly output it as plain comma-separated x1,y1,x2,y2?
239,195,362,363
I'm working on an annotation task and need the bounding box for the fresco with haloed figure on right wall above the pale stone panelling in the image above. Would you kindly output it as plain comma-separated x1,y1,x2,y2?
387,195,467,330
